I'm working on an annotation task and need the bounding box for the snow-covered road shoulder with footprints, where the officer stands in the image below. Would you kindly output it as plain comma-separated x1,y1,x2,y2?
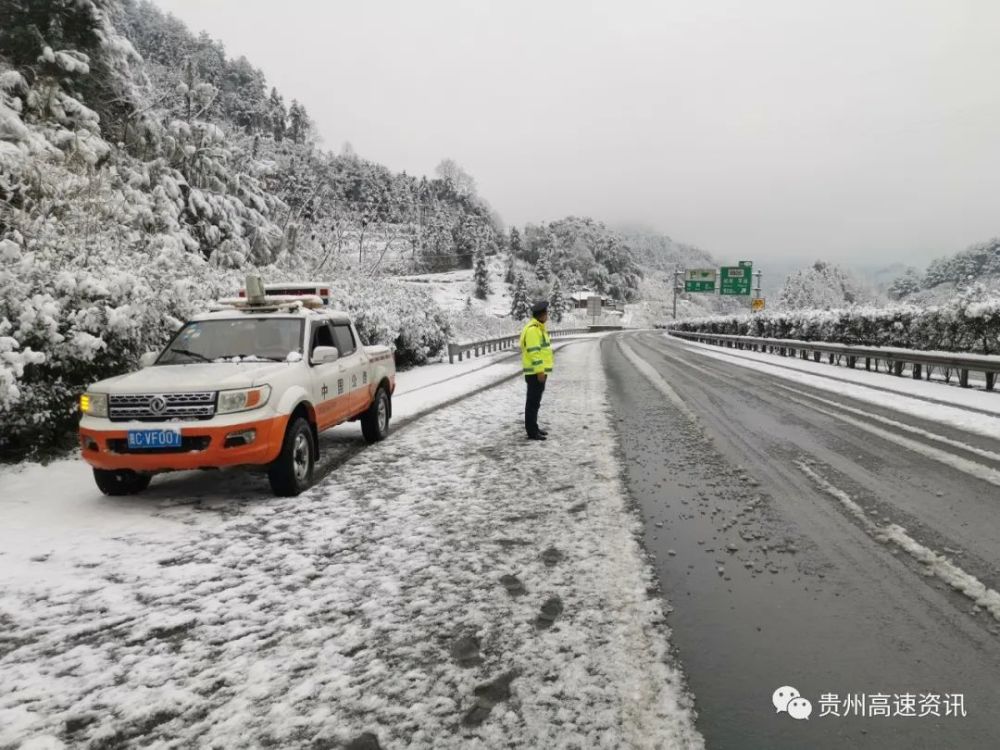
0,342,702,748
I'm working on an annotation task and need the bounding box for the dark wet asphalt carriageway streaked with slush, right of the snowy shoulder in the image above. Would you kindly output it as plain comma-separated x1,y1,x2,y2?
602,333,1000,750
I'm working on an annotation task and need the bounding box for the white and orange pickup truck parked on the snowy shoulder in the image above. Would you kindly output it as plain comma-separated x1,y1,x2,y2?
80,283,396,496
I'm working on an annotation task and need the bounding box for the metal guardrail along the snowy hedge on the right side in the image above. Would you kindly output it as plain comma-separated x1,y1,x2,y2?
667,329,1000,391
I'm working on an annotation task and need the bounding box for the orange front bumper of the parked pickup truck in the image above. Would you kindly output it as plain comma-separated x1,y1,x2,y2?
80,415,288,473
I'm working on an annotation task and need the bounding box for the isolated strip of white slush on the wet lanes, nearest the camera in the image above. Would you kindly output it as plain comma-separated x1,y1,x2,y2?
795,461,1000,621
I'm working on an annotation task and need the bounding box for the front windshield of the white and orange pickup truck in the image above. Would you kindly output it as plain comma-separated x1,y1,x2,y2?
156,318,302,365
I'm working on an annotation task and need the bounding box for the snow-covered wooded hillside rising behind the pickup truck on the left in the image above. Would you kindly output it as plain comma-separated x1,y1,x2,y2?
0,0,724,459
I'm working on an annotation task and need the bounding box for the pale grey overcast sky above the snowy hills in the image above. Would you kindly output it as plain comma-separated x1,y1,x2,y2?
156,0,1000,263
